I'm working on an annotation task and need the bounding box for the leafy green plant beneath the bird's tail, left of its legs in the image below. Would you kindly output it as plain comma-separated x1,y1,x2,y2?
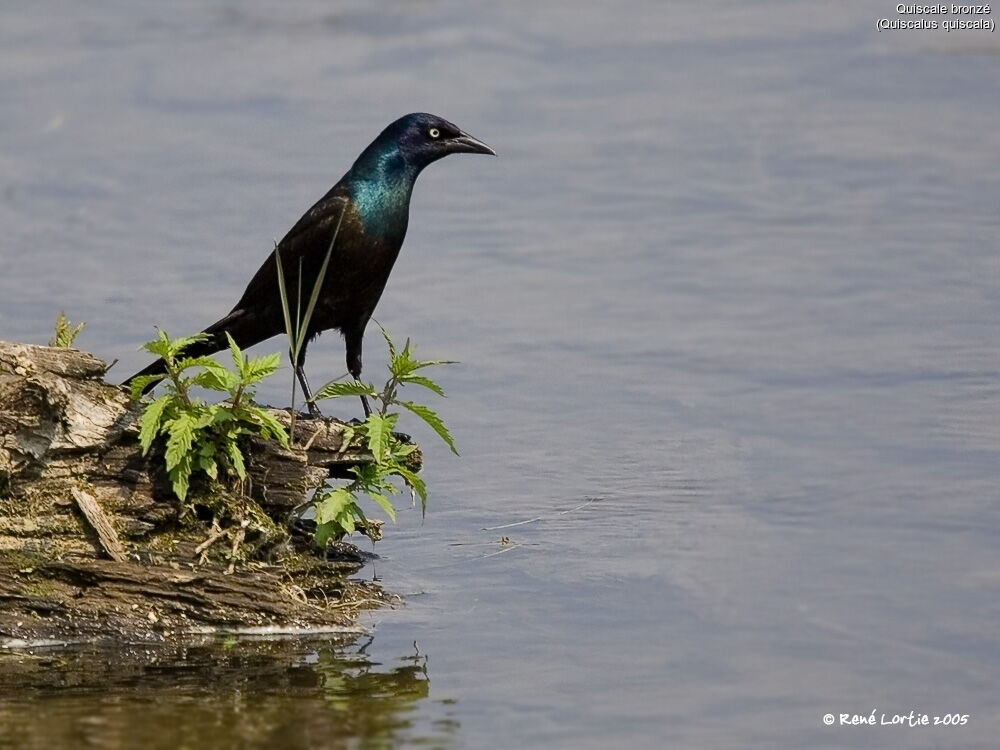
131,331,288,500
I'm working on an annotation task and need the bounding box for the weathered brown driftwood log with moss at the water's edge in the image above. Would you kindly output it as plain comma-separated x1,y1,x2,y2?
0,341,408,645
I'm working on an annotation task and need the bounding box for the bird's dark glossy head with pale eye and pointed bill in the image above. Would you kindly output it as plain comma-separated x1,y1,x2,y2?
358,112,496,178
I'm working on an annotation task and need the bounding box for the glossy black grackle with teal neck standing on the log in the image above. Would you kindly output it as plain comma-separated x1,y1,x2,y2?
125,113,496,416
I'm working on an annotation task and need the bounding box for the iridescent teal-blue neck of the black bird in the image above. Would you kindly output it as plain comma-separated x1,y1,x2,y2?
347,144,420,241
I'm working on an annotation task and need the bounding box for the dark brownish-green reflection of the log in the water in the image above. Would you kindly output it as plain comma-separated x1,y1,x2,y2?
0,640,458,748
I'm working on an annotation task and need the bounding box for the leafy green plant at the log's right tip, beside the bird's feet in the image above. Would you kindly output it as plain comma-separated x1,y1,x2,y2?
313,324,458,547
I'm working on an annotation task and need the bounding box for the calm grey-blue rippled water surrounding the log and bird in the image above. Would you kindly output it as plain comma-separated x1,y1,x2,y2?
0,0,1000,748
